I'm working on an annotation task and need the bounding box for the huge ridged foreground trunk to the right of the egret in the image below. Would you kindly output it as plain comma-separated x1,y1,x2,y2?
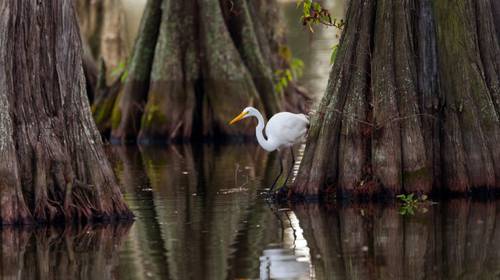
292,0,500,197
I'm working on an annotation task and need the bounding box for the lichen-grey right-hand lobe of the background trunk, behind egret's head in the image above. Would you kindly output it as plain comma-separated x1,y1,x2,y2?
199,0,266,139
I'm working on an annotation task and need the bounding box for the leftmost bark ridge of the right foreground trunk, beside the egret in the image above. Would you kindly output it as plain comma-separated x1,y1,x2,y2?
293,0,374,196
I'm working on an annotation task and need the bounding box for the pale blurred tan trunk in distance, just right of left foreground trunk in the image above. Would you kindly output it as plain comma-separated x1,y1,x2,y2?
76,0,130,107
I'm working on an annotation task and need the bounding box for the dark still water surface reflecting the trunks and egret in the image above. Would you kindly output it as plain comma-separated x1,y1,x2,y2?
0,145,500,279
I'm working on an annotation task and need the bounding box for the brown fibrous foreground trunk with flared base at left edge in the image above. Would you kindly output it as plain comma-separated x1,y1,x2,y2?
0,0,131,224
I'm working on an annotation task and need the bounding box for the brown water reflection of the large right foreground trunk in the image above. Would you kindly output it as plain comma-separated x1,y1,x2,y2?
294,200,500,279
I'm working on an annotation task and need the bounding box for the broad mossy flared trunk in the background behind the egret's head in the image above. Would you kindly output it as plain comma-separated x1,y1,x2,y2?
93,0,309,143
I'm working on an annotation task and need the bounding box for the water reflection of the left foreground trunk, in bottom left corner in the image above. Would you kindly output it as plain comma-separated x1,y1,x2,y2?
0,224,130,280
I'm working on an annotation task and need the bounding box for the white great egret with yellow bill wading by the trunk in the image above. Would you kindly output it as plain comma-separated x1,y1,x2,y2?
229,107,309,192
